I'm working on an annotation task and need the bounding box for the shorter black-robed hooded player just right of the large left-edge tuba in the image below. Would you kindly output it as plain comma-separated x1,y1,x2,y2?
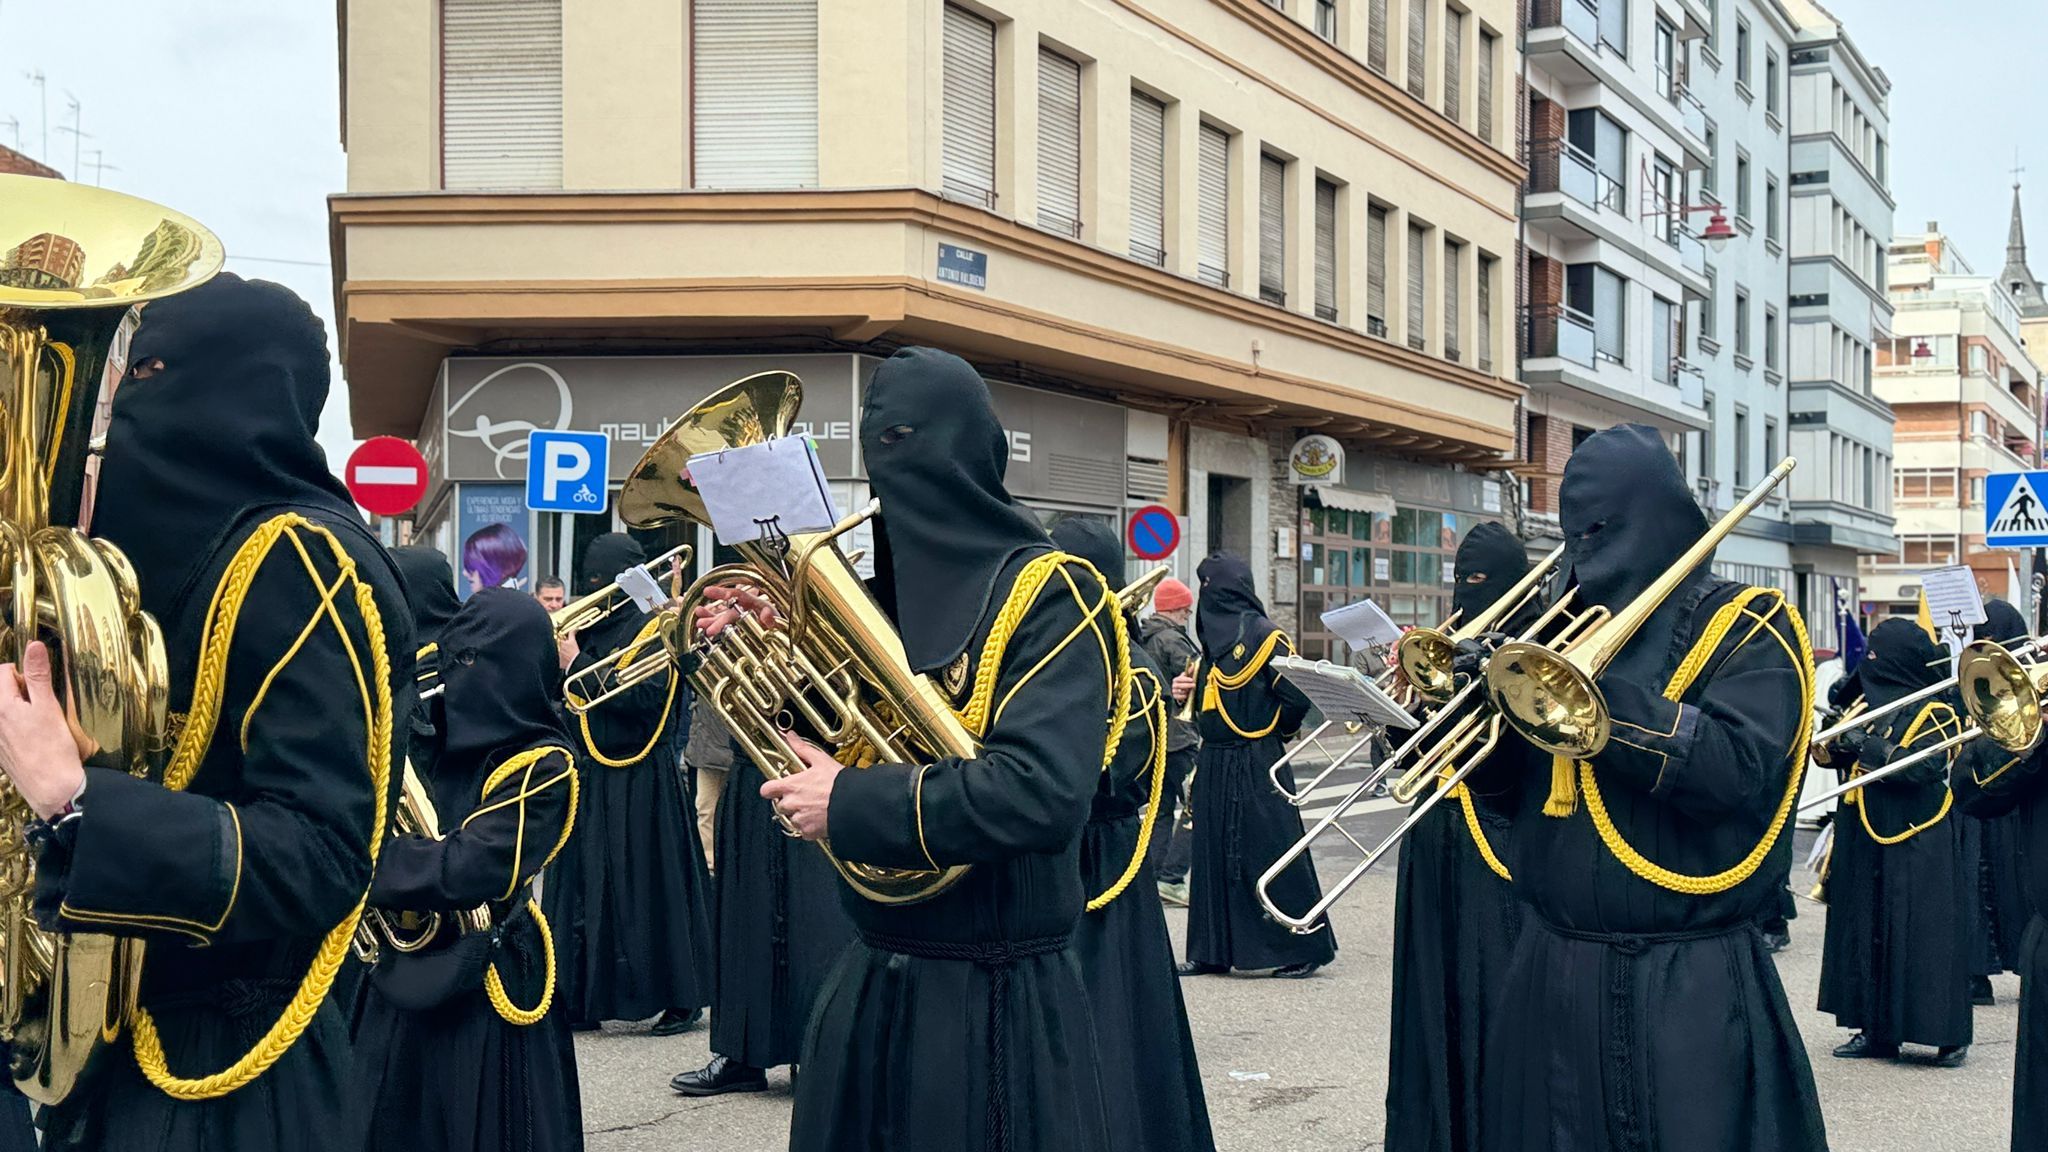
350,588,584,1152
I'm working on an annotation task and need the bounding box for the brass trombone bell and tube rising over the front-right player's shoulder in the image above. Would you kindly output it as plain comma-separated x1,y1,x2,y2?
1485,457,1798,760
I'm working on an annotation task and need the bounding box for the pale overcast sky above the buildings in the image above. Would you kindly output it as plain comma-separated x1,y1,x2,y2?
0,0,2048,467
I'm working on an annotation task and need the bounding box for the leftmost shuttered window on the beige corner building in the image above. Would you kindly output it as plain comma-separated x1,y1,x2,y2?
440,0,561,189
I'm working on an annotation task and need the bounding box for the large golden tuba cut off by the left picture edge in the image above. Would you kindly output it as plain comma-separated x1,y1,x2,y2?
0,176,223,1105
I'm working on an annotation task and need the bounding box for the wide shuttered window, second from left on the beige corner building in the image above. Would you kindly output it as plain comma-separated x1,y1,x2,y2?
690,0,817,189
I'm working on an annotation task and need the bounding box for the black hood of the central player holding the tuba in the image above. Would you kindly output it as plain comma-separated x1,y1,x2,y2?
860,348,1051,672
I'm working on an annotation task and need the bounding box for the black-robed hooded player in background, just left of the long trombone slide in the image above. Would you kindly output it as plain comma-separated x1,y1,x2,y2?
1188,551,1337,970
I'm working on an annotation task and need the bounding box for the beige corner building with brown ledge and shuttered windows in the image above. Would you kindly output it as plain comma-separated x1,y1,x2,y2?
330,0,1522,619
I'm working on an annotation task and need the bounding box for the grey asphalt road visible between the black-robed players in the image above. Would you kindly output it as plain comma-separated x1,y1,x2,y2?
578,795,2017,1152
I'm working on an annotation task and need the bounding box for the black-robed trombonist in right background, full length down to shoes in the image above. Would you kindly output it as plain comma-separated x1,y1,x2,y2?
1819,619,1978,1047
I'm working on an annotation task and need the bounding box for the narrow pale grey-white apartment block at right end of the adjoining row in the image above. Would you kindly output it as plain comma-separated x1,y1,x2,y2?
1784,0,1896,648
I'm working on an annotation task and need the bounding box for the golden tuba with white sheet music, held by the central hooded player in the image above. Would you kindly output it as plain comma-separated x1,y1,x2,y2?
618,371,977,904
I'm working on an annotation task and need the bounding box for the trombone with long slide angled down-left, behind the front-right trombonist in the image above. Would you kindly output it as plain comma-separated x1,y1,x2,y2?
1255,547,1587,935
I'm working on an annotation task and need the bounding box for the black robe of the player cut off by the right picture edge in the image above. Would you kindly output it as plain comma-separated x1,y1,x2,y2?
1954,725,2048,1152
